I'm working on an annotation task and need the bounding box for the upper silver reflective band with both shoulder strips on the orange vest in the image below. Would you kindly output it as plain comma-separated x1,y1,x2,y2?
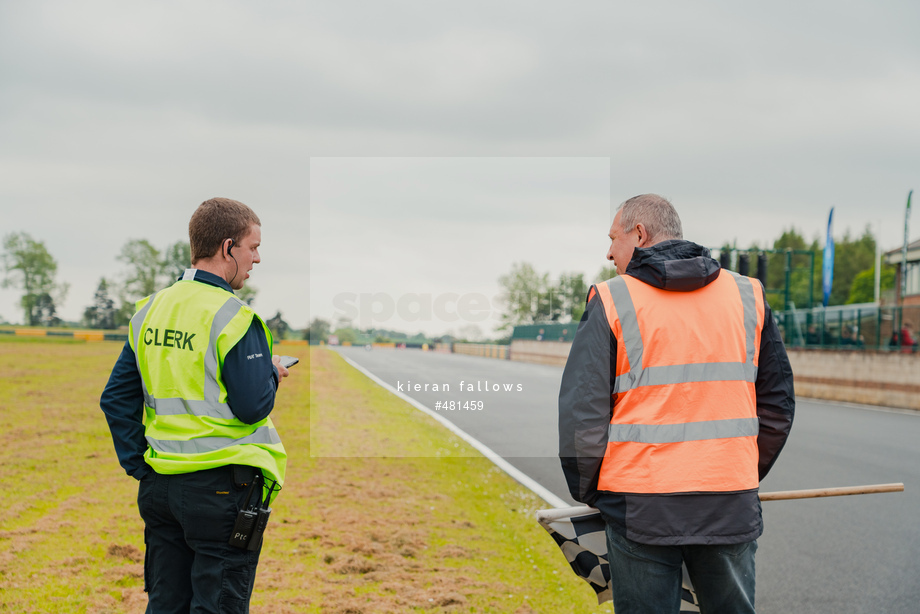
607,271,757,393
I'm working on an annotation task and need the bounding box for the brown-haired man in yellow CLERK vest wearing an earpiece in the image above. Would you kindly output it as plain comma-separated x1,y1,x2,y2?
100,198,288,613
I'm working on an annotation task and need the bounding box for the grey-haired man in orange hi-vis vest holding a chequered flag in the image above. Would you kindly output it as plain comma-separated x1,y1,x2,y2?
559,194,795,614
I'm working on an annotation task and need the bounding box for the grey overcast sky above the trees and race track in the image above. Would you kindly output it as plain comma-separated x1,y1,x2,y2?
0,0,920,332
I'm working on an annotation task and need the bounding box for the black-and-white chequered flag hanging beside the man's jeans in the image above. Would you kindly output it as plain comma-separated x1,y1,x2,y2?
537,505,700,613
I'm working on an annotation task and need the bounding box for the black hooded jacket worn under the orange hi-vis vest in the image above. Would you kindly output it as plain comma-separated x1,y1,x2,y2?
559,241,795,545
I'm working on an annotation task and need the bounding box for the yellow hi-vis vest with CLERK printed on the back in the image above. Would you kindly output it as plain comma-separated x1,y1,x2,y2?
128,269,287,494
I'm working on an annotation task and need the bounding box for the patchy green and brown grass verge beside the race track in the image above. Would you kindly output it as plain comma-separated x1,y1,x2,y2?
0,338,609,614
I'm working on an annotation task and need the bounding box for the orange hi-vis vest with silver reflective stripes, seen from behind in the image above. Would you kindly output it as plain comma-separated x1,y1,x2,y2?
596,269,764,494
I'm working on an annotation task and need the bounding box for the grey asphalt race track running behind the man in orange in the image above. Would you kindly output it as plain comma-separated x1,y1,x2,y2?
338,348,920,614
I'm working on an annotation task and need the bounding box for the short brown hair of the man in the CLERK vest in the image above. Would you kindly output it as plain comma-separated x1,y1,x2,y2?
188,198,262,264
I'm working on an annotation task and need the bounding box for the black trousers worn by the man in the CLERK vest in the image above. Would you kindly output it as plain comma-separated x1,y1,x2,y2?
137,466,261,614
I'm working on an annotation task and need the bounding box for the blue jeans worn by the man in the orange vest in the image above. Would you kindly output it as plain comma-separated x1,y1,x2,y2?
607,524,757,614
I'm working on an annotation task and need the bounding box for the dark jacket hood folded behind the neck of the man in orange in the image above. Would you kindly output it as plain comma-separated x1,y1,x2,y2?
625,240,722,292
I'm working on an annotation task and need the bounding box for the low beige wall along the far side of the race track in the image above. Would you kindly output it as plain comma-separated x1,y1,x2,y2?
511,339,920,411
